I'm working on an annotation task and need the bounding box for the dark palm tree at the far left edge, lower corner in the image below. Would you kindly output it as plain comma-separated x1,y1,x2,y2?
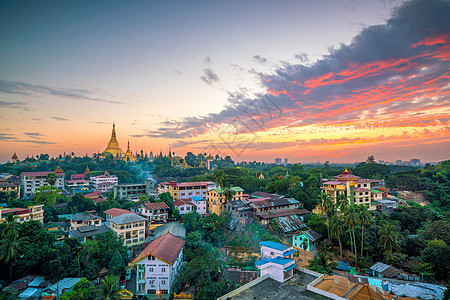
0,229,28,279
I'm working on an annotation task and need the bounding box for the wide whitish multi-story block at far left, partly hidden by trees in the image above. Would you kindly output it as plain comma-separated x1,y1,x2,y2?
20,167,64,197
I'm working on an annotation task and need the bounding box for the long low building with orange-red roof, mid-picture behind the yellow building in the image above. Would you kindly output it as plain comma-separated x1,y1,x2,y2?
158,181,217,199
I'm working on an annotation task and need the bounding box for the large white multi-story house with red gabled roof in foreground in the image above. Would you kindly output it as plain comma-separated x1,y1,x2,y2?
130,233,185,295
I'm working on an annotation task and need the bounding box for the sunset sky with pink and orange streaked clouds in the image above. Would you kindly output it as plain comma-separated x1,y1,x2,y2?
0,0,450,163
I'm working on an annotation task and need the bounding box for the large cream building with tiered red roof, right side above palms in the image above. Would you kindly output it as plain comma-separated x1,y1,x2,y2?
321,169,384,210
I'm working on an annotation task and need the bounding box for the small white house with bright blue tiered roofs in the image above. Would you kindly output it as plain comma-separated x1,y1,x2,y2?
255,241,296,282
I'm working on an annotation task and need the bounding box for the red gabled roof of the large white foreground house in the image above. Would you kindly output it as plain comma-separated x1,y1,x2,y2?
131,233,184,265
